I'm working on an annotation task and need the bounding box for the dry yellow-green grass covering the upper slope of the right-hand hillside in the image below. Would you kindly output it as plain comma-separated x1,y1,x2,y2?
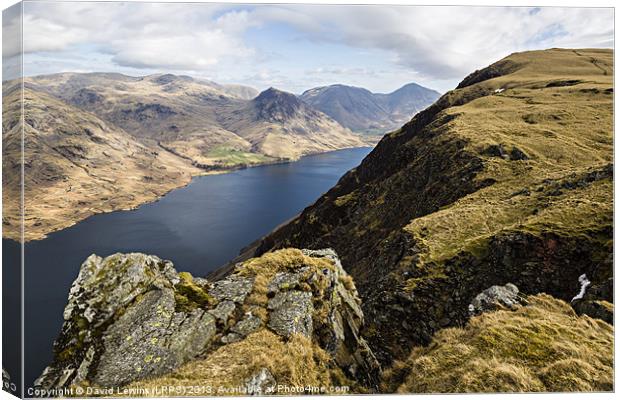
405,49,613,276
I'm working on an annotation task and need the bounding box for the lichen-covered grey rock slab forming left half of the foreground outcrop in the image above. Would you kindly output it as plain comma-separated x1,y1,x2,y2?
35,253,216,389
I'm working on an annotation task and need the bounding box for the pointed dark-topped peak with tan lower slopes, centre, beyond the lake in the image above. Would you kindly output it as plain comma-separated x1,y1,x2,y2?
220,88,365,159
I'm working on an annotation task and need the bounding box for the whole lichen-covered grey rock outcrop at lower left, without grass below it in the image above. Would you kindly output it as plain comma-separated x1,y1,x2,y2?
35,249,379,392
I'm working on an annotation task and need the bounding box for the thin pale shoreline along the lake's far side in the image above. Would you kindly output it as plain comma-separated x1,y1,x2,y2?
2,145,374,245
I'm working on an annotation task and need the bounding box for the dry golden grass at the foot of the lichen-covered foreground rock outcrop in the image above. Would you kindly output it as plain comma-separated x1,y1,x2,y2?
126,329,345,395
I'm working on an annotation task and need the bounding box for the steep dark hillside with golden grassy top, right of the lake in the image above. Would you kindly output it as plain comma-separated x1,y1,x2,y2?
246,49,613,365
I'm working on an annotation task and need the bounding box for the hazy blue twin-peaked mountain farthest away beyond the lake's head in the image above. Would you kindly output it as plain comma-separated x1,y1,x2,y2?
301,83,440,133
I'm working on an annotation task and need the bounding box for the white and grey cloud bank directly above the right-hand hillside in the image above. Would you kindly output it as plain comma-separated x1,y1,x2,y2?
251,6,614,79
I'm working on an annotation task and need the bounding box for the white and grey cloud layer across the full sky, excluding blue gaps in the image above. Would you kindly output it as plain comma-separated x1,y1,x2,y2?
17,2,614,81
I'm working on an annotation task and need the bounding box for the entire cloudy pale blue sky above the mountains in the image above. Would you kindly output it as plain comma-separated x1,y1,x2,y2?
3,2,614,93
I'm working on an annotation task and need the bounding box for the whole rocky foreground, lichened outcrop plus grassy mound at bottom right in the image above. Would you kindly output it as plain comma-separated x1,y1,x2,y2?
35,249,613,396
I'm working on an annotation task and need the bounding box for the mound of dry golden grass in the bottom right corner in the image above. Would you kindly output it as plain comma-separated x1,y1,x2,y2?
384,294,614,393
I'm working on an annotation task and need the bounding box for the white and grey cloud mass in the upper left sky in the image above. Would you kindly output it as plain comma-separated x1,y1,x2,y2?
24,3,254,70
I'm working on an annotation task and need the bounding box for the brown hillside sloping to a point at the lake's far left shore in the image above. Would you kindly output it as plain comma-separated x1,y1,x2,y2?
2,86,200,240
